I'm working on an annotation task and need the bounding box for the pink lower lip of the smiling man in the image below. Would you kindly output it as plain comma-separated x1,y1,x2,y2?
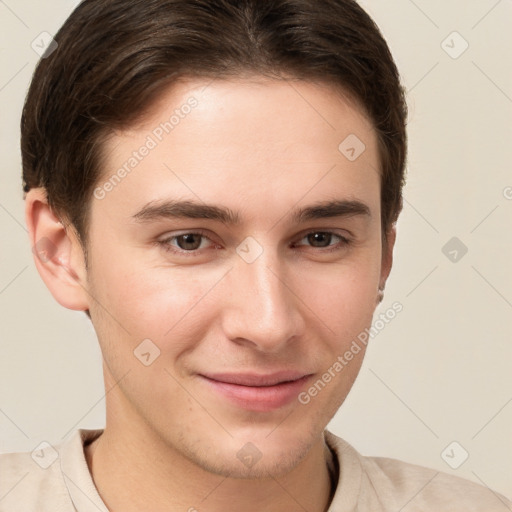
202,375,310,412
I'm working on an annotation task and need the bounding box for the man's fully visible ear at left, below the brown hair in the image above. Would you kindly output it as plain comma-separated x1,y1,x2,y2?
25,188,89,311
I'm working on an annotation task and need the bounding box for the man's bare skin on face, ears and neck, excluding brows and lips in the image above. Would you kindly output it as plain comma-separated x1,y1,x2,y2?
26,77,395,512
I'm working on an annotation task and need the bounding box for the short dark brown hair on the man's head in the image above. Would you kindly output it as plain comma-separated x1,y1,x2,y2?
21,0,407,249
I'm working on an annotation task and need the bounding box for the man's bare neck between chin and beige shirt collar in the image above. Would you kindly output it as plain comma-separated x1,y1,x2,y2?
85,423,334,512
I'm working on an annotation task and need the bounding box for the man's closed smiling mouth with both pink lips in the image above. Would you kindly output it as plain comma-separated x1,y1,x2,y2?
199,371,312,412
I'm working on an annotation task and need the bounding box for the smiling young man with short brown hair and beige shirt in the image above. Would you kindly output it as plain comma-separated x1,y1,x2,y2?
0,0,512,512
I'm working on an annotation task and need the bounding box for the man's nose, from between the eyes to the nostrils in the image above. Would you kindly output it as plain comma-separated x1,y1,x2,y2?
222,249,305,353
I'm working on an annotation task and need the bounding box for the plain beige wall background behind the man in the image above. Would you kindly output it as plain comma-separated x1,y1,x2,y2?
0,0,512,497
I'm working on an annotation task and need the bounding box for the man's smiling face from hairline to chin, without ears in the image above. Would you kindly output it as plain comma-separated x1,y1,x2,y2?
80,79,388,477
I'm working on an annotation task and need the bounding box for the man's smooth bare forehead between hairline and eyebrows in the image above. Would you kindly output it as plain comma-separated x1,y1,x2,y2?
98,79,380,226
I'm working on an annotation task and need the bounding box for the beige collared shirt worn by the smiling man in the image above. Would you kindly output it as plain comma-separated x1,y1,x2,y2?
0,429,512,512
